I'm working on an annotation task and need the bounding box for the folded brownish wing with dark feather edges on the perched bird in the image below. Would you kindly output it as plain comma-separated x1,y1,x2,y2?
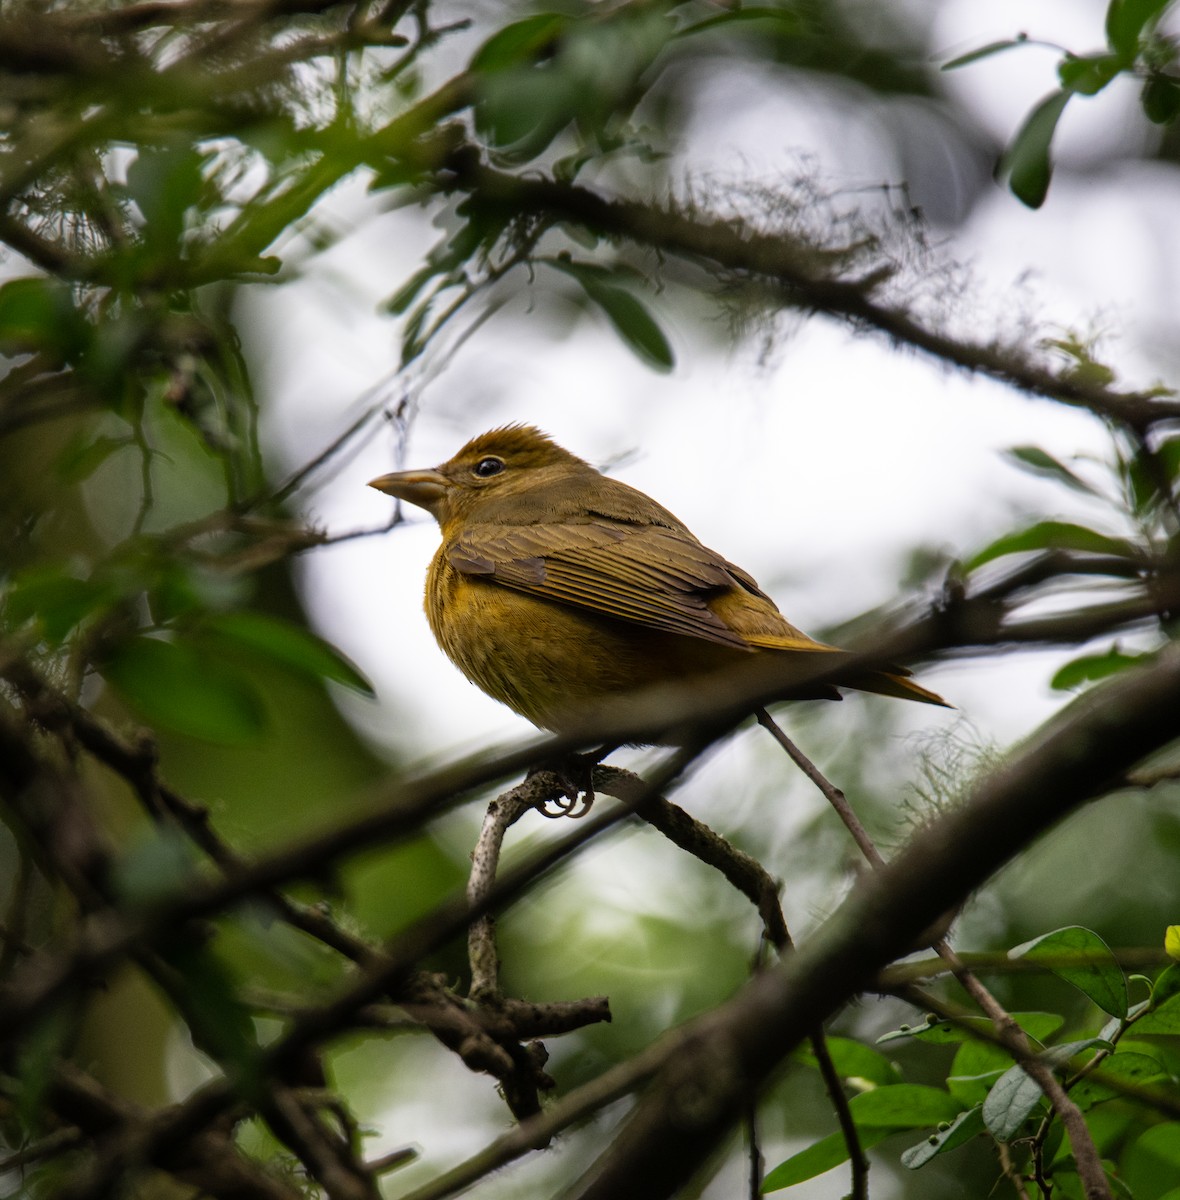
448,520,829,650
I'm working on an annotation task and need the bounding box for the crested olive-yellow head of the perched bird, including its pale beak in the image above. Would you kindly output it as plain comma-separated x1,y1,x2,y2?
369,425,598,530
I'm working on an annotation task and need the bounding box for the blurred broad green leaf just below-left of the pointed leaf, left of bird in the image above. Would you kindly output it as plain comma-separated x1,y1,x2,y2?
101,636,266,745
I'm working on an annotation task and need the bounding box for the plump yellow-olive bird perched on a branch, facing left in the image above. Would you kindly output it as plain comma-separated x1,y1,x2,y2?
370,425,946,732
